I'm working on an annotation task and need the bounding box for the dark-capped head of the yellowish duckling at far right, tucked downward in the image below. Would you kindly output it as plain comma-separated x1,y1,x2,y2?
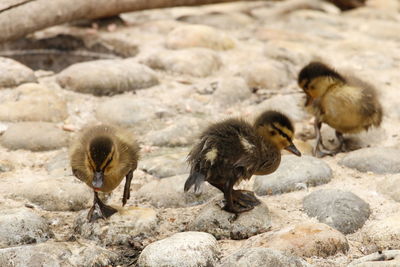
297,62,345,106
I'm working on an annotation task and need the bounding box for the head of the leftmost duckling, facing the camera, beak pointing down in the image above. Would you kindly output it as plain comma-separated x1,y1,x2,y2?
87,136,117,191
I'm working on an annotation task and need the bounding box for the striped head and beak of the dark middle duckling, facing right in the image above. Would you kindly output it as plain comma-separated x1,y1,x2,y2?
254,111,301,156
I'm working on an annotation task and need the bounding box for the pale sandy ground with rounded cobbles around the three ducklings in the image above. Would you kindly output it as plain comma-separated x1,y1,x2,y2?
0,0,400,266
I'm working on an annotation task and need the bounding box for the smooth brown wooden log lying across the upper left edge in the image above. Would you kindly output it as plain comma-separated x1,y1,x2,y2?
0,0,250,43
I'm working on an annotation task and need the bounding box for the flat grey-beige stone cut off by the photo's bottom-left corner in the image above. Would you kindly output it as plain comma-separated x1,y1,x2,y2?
0,241,119,267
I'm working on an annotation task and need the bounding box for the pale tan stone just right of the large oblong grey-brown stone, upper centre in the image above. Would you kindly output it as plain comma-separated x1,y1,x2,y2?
146,48,222,77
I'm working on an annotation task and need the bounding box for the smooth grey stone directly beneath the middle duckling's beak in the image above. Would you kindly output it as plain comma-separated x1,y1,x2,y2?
253,155,332,196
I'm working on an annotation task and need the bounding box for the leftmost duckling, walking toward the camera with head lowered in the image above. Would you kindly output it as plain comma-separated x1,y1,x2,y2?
70,125,139,222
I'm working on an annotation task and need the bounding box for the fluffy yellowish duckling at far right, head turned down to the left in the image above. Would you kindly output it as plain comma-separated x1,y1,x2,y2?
298,62,382,157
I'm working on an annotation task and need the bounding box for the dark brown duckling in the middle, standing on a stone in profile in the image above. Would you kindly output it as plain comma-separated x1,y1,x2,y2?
184,111,301,214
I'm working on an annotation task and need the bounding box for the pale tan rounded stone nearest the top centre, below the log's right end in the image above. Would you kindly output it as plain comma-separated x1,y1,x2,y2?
166,25,235,50
